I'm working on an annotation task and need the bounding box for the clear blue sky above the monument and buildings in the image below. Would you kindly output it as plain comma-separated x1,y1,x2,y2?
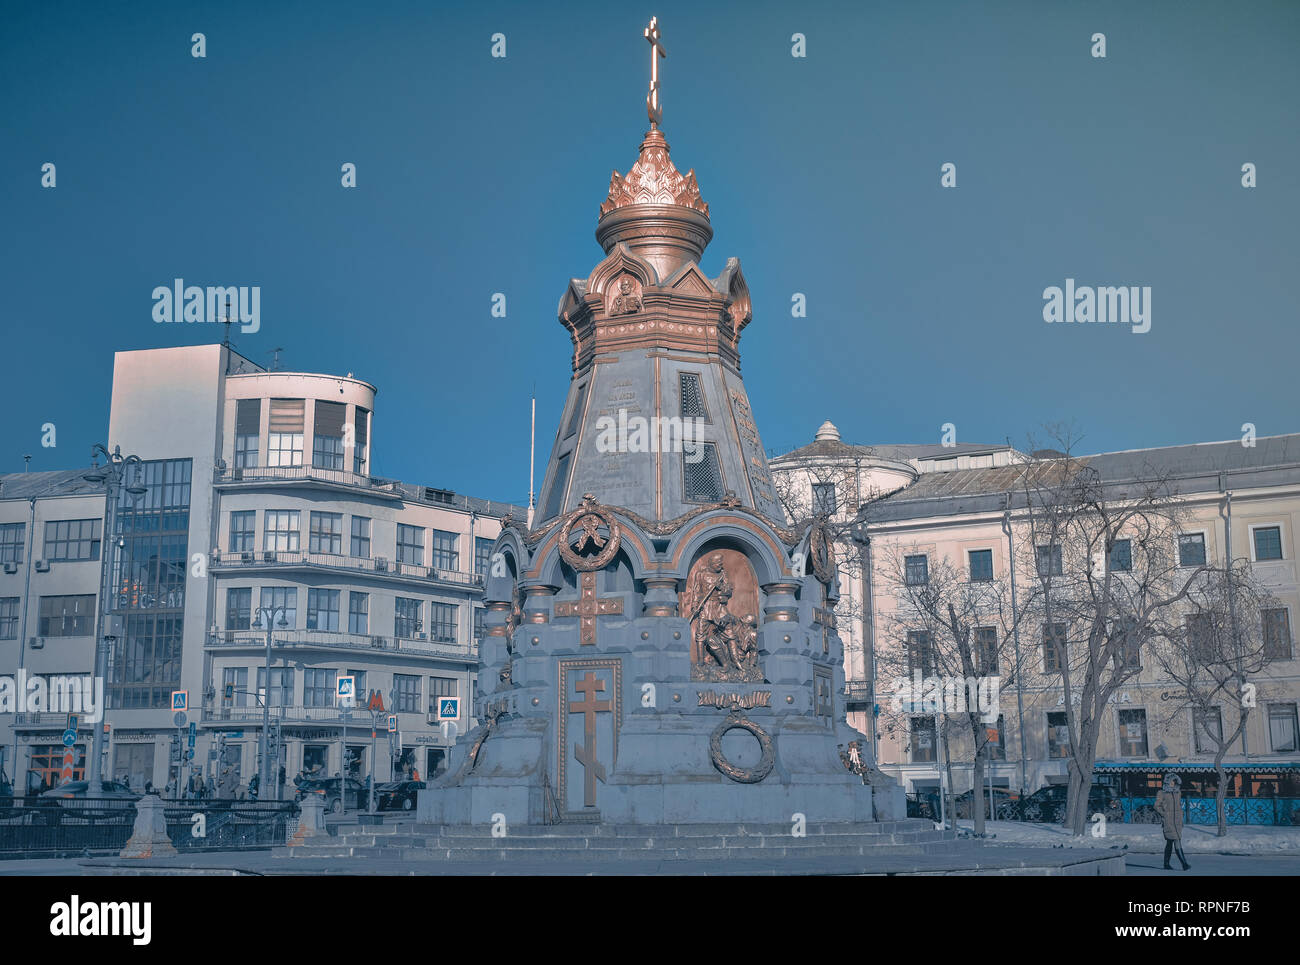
0,0,1300,501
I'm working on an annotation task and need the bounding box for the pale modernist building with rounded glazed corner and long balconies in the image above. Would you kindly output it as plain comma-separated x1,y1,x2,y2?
0,345,523,788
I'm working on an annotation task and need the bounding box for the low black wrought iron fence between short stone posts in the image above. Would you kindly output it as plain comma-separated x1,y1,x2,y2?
0,797,299,858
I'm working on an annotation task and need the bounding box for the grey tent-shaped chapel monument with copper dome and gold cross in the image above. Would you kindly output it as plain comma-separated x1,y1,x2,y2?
417,20,905,825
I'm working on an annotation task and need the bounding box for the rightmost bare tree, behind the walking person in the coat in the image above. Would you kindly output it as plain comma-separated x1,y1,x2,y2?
1152,561,1282,838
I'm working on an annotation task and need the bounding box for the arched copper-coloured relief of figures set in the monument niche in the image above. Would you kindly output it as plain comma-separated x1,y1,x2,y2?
679,550,763,683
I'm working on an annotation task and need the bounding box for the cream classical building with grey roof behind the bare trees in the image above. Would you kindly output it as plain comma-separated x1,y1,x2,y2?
772,423,1300,792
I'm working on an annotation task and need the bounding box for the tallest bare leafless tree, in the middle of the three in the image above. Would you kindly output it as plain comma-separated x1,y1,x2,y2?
1017,428,1205,835
